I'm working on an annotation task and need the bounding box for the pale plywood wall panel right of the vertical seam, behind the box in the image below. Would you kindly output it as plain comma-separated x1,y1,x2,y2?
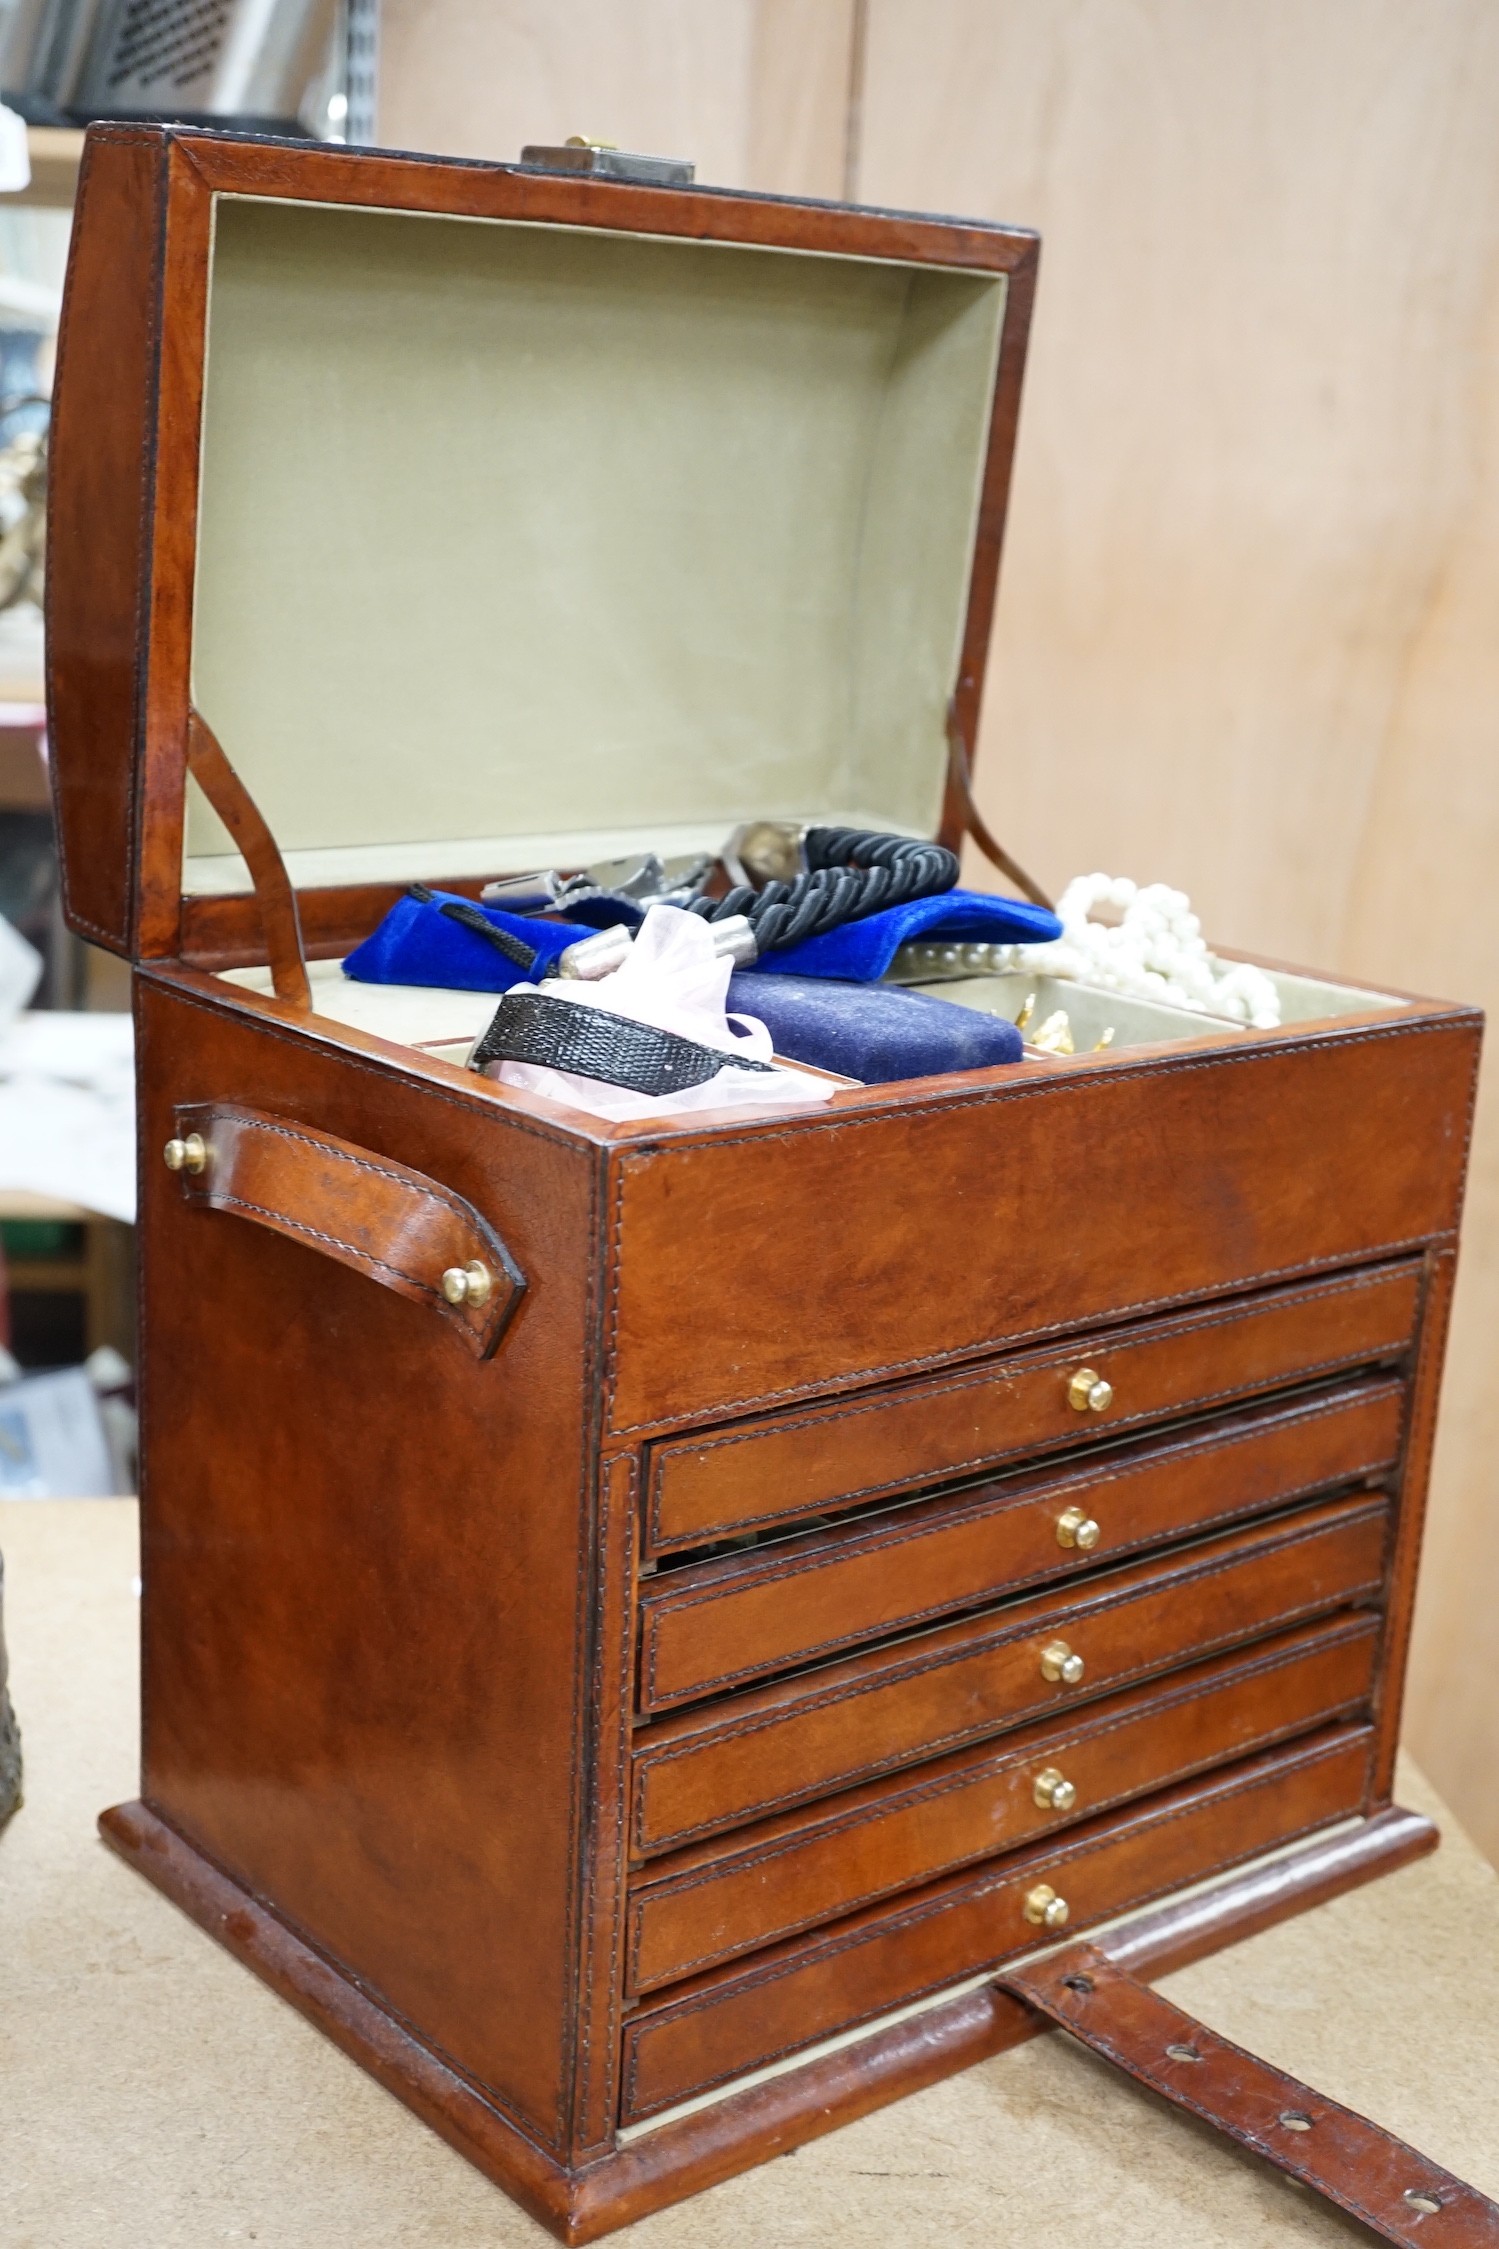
858,0,1499,1858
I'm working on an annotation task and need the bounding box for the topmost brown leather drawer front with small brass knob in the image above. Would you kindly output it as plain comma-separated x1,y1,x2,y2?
645,1264,1420,1554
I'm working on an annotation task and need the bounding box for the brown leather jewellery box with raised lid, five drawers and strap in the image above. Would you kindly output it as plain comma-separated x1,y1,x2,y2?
47,128,1492,2242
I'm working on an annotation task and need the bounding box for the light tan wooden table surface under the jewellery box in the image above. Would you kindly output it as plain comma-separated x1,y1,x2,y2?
0,1500,1499,2249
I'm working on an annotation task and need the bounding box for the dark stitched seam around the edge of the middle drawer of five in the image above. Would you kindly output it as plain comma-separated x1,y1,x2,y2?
636,1500,1389,1853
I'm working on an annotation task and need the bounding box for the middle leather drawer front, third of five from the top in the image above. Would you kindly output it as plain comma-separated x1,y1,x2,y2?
632,1498,1389,1858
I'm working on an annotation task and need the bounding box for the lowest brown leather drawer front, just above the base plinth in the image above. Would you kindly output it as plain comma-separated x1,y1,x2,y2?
620,1725,1373,2123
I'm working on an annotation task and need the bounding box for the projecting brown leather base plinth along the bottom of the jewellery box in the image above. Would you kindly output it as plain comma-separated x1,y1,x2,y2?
99,1804,1438,2242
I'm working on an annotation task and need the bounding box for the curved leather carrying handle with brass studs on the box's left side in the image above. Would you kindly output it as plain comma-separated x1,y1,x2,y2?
169,1102,526,1358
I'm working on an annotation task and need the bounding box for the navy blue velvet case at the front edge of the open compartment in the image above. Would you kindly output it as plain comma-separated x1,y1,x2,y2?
728,971,1020,1086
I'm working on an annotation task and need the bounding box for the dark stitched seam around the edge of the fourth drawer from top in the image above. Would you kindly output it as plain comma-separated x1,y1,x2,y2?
629,1617,1378,1986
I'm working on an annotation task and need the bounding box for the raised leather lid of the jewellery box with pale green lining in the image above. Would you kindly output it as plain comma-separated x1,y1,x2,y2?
47,126,1038,960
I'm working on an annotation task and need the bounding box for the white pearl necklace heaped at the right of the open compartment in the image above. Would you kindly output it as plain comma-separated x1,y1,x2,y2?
930,875,1281,1030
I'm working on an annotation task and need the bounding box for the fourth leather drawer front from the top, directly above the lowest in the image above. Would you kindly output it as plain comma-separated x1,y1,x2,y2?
627,1610,1380,1993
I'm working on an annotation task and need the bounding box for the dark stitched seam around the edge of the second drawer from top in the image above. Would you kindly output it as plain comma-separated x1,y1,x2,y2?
641,1385,1398,1707
